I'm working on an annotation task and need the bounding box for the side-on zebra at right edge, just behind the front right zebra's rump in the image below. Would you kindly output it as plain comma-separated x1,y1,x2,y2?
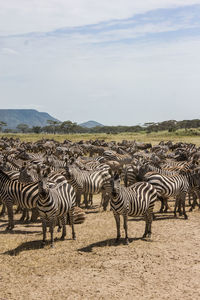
144,171,200,219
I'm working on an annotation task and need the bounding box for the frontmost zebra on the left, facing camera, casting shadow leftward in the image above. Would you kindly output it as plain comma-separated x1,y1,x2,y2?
37,170,76,247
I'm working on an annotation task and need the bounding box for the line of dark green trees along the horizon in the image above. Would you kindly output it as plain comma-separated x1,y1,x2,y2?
0,119,200,134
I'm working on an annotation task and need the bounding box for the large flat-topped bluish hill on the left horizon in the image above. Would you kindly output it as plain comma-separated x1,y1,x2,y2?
0,109,58,129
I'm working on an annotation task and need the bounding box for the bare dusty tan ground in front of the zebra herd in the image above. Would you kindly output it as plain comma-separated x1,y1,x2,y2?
0,197,200,300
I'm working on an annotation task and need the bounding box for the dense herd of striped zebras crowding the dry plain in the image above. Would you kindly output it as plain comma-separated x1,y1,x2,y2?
0,138,200,247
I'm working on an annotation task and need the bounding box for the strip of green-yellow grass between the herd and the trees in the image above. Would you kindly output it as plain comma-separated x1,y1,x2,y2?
0,130,200,146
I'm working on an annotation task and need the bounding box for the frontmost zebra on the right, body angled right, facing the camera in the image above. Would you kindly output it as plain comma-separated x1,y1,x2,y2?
105,176,157,244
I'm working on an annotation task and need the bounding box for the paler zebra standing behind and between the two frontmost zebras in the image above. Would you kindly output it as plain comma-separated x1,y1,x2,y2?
65,166,111,208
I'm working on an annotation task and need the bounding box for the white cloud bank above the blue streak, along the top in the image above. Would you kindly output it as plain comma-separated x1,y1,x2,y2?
0,0,200,35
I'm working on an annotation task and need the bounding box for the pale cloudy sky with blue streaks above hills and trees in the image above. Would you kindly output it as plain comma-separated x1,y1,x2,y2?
0,0,200,126
